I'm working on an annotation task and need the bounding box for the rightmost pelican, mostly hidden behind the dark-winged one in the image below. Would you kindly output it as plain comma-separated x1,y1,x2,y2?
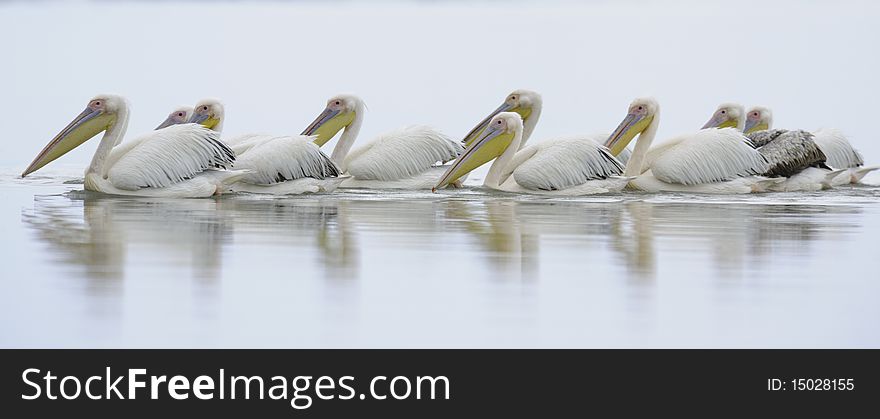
745,106,880,186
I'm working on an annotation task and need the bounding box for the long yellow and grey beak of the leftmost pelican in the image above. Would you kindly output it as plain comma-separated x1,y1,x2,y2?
21,108,115,177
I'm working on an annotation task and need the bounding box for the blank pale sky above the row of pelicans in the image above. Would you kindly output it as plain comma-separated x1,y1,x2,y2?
0,1,880,176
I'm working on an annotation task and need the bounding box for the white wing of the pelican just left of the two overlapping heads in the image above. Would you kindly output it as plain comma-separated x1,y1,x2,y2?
344,126,464,181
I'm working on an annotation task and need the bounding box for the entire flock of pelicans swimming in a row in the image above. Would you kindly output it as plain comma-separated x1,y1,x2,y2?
22,90,878,197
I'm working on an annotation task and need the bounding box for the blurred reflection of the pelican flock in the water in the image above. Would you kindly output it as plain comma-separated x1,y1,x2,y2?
23,192,861,289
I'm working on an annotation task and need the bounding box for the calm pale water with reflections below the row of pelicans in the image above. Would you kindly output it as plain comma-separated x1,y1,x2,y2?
0,170,880,347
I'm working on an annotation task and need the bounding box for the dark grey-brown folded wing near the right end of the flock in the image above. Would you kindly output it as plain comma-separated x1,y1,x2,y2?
748,129,825,177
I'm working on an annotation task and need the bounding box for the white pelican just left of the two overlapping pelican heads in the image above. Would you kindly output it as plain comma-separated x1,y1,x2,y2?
302,95,463,189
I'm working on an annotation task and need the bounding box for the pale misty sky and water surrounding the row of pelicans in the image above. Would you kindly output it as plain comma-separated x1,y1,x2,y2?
0,1,880,348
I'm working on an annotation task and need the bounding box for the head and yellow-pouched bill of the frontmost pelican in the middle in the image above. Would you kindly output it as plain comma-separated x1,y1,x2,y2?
431,112,523,191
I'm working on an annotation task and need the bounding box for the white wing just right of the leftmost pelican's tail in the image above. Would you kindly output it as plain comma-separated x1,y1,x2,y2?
235,135,339,185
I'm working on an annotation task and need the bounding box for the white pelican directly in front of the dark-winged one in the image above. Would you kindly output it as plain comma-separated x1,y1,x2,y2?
605,98,779,193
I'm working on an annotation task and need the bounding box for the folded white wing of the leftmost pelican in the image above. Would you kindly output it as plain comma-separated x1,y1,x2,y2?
107,124,235,191
